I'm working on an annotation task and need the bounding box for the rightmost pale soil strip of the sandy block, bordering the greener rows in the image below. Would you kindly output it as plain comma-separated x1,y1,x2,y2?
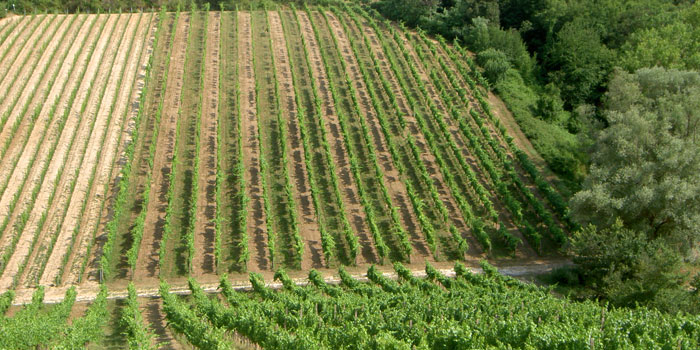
64,14,156,284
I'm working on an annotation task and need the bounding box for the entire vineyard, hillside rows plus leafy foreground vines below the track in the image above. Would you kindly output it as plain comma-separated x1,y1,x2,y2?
0,3,672,349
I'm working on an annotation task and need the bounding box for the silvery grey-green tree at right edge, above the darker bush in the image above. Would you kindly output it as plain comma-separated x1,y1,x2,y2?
571,68,700,252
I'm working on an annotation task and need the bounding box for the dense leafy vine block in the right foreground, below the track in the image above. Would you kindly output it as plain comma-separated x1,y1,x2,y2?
161,263,700,349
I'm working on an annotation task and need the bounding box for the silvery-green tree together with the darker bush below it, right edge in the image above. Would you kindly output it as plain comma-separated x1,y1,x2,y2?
571,68,700,312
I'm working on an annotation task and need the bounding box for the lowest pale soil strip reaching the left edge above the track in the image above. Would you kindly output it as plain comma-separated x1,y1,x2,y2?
0,16,100,276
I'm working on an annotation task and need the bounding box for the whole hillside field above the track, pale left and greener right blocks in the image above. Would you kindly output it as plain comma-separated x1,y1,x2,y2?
0,4,572,346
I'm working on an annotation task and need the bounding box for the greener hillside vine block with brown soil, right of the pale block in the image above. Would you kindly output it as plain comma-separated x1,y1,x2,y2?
93,4,575,278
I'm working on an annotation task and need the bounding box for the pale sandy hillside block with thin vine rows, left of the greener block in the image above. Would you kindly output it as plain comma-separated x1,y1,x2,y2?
0,13,156,290
